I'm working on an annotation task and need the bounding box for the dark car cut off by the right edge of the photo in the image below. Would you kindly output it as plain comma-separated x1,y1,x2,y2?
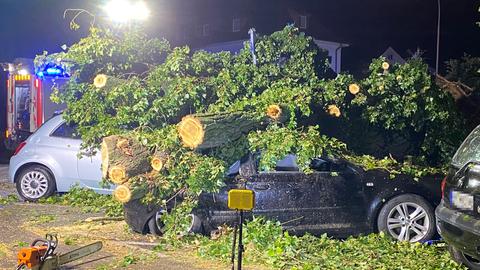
435,126,480,269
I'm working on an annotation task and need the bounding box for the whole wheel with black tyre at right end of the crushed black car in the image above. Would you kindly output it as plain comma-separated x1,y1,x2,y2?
377,194,435,242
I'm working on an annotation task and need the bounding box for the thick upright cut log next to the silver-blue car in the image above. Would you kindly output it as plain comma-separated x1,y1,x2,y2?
101,135,151,181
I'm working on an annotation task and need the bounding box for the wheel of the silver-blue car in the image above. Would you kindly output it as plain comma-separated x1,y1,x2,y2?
15,165,57,202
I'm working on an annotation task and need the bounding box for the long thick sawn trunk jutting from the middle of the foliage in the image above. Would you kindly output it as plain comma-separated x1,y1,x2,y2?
177,112,269,149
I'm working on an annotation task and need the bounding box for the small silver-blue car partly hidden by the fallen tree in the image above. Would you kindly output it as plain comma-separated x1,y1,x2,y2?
8,115,112,201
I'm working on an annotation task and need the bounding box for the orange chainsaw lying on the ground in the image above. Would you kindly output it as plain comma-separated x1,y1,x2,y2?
16,234,102,270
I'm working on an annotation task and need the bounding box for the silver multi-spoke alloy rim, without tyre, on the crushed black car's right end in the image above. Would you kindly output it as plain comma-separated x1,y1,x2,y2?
387,202,430,242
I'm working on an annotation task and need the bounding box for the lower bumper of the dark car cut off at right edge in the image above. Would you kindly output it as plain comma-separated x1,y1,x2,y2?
435,201,480,259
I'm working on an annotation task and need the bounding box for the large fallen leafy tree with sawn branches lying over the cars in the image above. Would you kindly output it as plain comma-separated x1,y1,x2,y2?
37,26,466,234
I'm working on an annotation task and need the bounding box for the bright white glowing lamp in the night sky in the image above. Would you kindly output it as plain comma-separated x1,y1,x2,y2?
103,0,150,23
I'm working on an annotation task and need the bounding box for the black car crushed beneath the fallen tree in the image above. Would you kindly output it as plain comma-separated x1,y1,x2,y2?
125,155,441,242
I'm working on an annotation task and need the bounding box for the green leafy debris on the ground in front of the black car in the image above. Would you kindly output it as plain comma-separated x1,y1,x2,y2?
198,218,464,269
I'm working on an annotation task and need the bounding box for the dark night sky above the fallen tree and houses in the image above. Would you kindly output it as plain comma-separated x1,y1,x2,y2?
0,0,480,74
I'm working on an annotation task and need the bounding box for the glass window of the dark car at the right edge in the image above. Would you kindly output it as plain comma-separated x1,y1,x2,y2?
452,126,480,167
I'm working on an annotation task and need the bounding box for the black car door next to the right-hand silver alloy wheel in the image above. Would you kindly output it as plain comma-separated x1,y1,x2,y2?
298,160,367,237
